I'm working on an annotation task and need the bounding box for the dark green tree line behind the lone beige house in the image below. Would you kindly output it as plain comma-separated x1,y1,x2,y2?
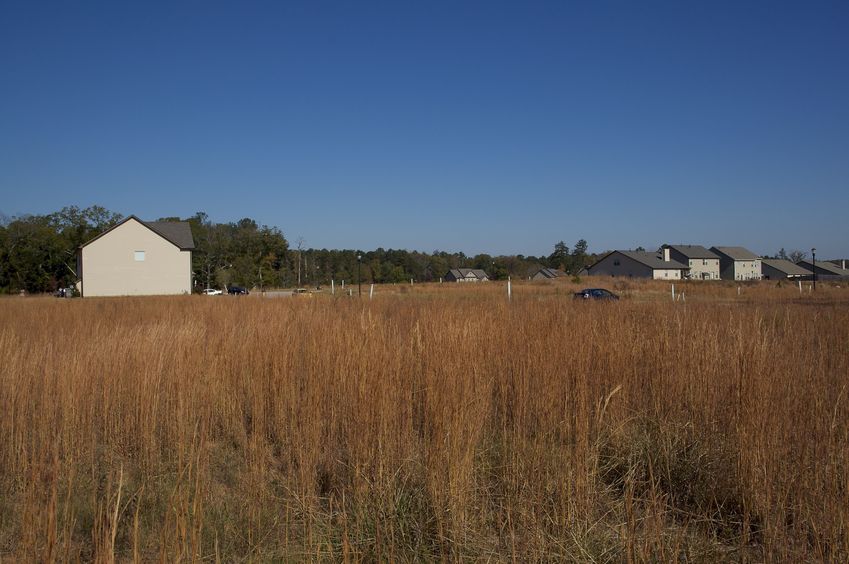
0,206,597,293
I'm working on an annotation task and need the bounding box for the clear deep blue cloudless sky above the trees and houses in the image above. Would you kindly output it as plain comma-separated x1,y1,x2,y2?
0,1,849,258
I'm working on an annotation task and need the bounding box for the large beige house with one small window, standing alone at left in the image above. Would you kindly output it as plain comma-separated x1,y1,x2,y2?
77,215,195,297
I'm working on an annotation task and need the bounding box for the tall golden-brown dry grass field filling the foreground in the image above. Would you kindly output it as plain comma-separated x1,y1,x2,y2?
0,281,849,562
